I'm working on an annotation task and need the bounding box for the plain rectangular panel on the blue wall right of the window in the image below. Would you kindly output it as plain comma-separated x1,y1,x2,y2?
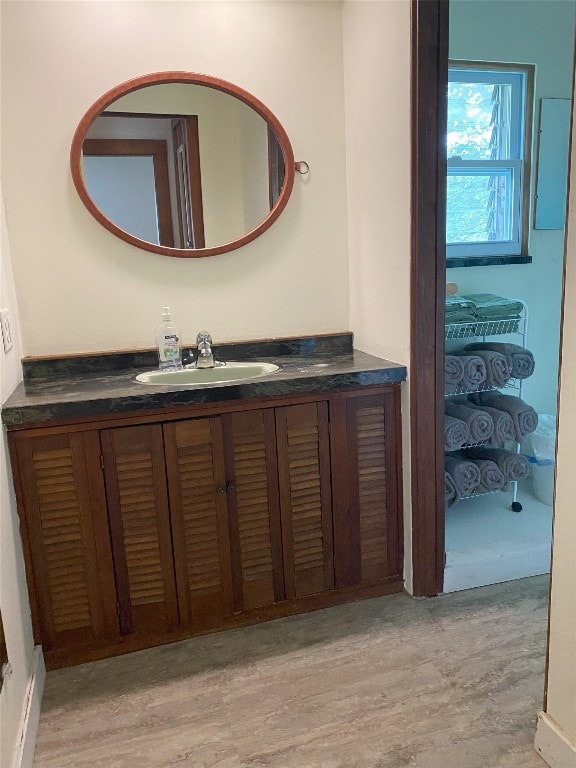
534,99,572,229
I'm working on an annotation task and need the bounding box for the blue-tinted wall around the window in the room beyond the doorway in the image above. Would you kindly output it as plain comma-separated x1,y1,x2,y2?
446,0,576,413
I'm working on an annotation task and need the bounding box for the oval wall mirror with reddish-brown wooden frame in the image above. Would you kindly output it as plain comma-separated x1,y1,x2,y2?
70,72,295,258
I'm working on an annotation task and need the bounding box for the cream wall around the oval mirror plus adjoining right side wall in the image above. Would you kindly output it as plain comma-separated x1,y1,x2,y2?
2,0,411,585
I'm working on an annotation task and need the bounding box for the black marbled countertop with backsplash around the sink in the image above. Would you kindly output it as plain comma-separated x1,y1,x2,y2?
2,335,406,429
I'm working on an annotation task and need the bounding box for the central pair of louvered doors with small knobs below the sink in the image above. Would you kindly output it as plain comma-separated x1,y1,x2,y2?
164,409,284,626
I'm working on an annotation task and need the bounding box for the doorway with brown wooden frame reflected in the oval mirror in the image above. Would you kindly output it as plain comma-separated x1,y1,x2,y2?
82,112,205,248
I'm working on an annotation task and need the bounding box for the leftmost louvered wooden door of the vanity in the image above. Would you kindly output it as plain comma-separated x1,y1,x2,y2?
12,431,119,651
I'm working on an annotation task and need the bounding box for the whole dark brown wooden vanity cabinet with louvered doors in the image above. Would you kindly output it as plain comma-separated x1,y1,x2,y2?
10,385,402,666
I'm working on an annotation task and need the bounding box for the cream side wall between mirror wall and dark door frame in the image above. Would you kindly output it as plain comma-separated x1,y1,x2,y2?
343,0,412,589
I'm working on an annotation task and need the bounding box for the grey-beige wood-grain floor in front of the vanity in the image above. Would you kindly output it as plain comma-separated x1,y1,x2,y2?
34,576,548,768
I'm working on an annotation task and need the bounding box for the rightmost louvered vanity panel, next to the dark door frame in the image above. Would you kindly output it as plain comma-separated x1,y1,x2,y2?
331,387,401,587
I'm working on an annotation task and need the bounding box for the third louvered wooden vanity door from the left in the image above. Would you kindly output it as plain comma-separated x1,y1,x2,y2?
164,417,233,628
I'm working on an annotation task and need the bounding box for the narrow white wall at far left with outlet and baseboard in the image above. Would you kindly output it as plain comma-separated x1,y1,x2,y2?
0,194,43,768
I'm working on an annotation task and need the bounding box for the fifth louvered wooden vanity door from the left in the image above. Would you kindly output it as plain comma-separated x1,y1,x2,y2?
276,402,334,598
